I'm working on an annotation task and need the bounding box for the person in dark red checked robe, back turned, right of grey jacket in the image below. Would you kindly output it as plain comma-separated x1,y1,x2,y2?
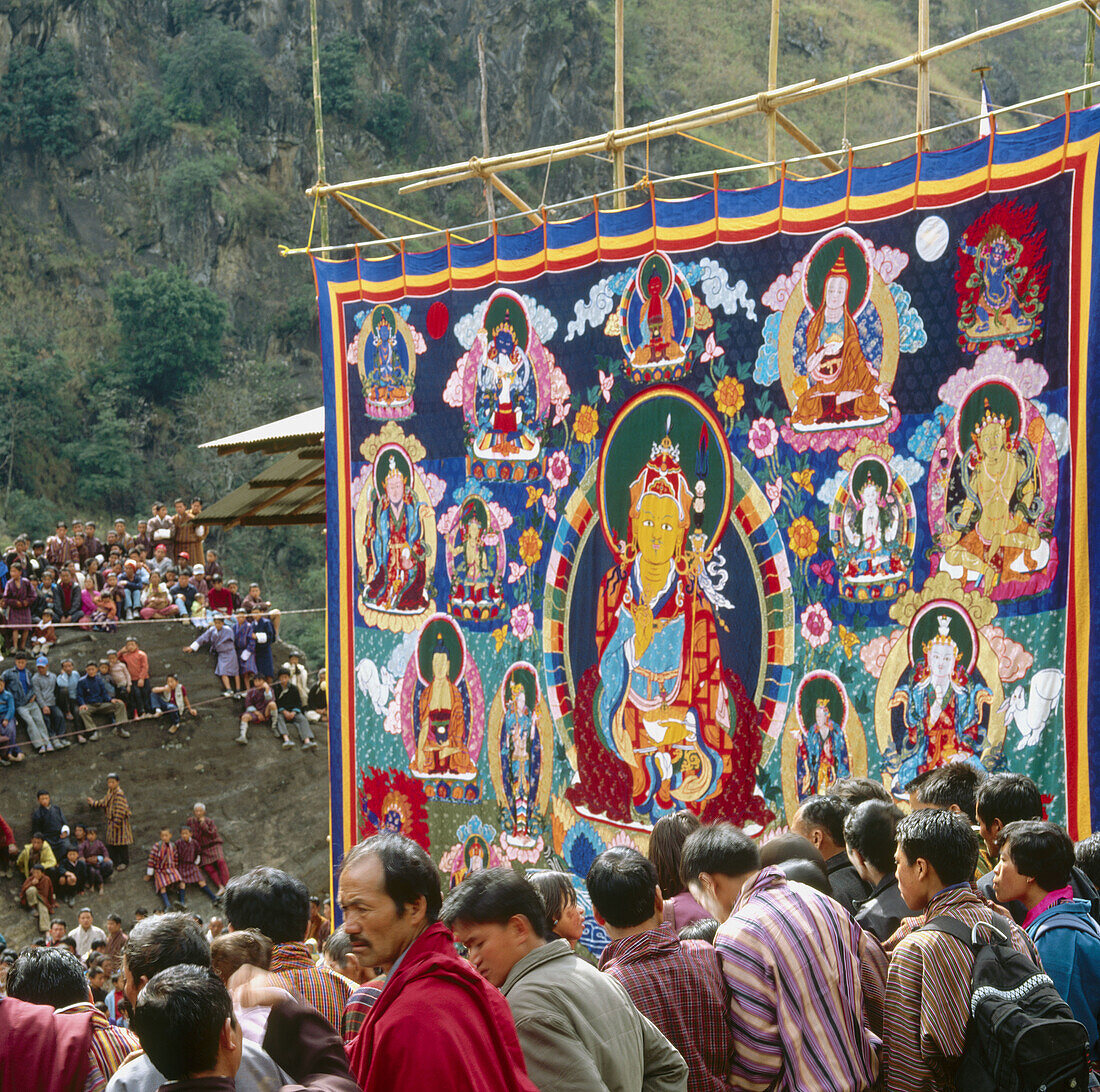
585,846,734,1092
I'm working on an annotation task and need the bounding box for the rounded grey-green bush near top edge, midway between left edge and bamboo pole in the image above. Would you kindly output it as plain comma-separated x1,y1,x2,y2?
164,19,267,125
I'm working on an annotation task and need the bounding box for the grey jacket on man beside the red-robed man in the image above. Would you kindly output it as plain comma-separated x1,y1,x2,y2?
501,939,688,1092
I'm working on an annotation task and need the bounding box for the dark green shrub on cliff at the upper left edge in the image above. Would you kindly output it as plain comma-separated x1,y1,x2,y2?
0,42,87,159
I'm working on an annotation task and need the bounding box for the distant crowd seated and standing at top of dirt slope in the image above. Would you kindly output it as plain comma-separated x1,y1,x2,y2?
0,498,328,766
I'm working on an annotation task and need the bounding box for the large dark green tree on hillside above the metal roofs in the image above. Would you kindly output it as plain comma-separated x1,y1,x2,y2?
111,269,226,402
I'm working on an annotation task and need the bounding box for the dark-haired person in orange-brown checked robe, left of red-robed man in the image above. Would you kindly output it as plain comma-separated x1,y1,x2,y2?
217,868,354,1028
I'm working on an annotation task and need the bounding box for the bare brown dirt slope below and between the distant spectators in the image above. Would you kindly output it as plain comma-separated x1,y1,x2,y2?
0,621,329,945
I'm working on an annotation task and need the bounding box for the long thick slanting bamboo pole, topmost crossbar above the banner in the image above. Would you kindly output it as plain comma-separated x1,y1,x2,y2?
306,0,1092,197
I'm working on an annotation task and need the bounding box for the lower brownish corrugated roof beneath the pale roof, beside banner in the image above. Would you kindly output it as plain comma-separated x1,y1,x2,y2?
202,444,325,527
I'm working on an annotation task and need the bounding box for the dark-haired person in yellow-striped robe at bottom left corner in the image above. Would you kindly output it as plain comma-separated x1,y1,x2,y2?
8,948,140,1092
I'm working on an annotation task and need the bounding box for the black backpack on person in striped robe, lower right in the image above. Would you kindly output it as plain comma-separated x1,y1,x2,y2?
919,916,1089,1092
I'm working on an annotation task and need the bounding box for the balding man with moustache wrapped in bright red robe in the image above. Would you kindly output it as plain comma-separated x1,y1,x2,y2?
339,834,537,1092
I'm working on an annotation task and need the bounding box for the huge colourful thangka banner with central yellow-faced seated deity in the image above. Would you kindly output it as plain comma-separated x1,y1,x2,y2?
315,112,1100,945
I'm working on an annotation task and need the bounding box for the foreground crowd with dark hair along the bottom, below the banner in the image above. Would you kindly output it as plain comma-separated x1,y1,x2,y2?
0,763,1100,1092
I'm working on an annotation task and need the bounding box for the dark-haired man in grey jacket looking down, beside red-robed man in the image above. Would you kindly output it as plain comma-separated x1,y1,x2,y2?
440,868,688,1092
